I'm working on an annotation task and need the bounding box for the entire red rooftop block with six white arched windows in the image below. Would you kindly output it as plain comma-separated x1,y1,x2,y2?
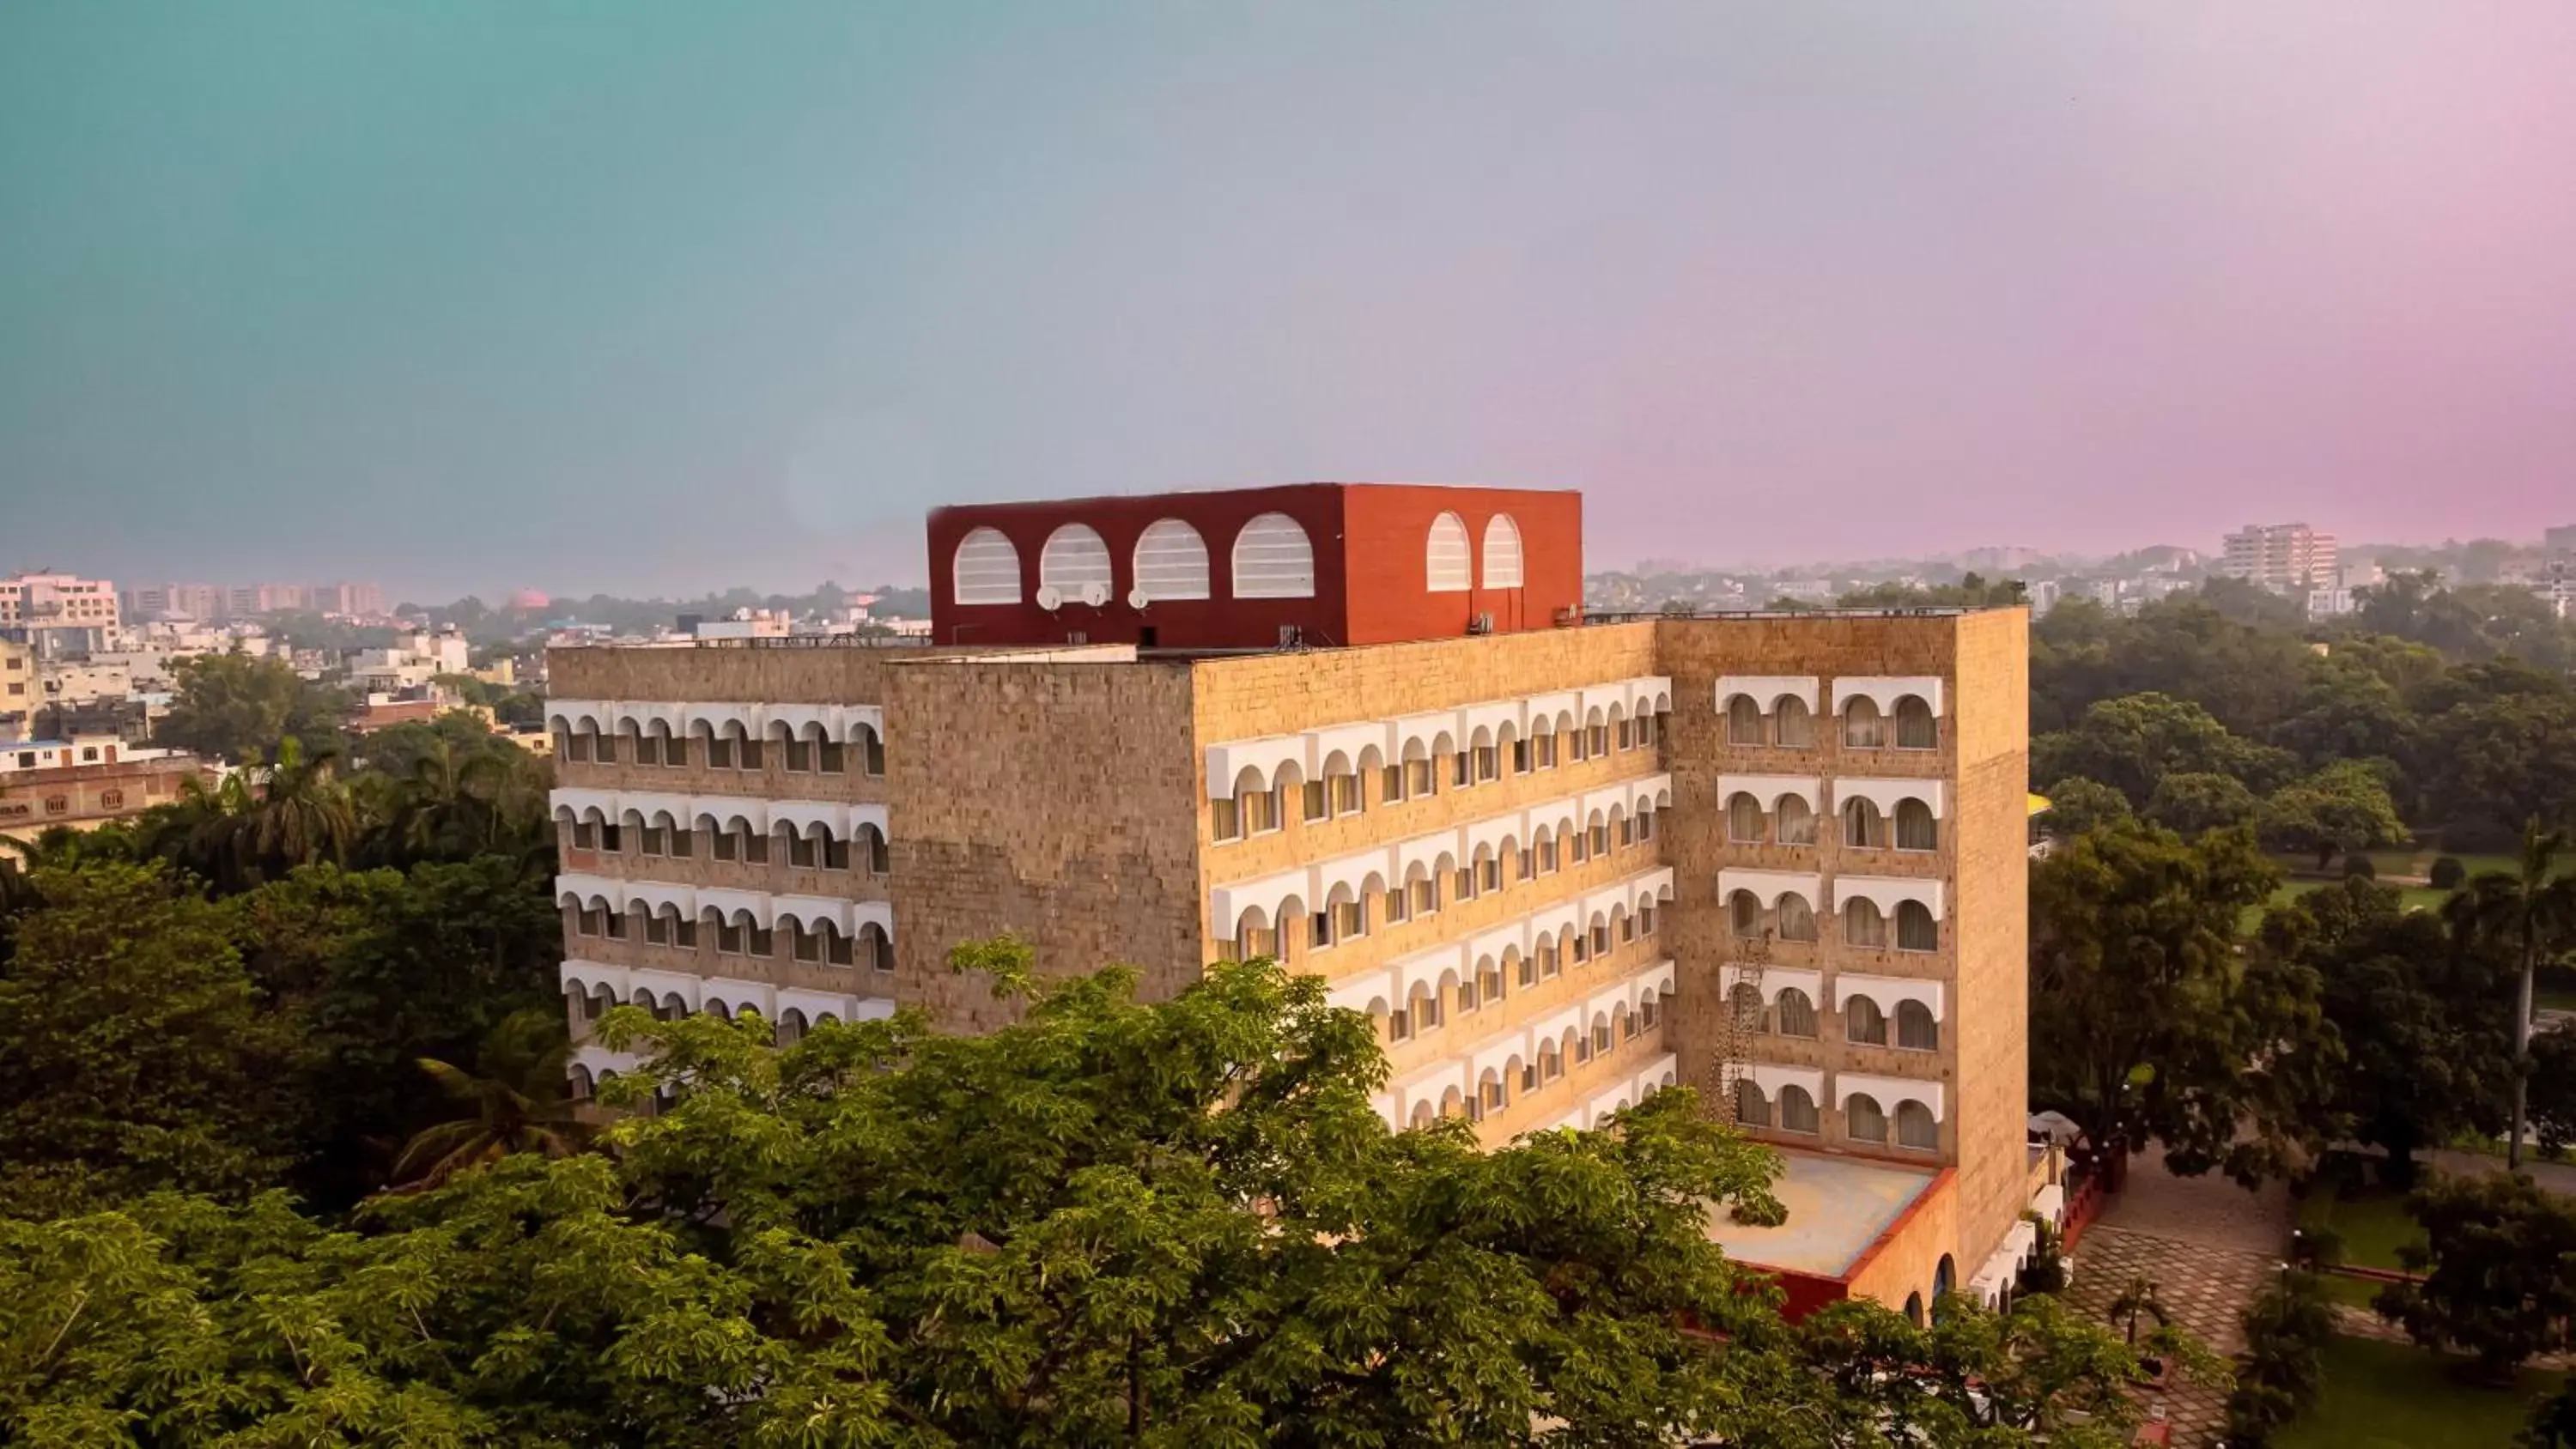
930,484,1584,649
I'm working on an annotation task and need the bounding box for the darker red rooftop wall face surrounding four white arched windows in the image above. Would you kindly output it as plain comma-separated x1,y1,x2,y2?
930,484,1370,649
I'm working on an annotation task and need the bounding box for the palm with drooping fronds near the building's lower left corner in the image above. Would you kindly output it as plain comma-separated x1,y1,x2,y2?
394,1006,590,1191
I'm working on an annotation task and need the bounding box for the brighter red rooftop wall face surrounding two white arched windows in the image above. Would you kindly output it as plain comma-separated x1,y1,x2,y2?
1342,484,1584,644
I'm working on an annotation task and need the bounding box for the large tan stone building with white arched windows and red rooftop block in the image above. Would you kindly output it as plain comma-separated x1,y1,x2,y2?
549,484,2061,1313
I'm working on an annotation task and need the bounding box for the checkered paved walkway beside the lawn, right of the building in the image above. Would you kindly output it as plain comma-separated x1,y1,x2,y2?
2066,1153,2293,1446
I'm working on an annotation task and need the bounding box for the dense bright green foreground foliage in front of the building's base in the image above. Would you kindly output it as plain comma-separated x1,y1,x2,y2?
0,962,2205,1449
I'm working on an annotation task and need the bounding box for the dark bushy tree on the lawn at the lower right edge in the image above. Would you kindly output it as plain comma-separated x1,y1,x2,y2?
2372,1173,2576,1379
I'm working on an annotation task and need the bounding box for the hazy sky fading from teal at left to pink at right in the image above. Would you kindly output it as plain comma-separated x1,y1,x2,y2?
0,0,2576,597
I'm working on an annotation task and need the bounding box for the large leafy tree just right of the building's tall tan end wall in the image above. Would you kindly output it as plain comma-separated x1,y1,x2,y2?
2030,821,2342,1184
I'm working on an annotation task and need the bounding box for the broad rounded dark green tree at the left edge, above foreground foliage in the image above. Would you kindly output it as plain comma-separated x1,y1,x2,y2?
0,862,291,1212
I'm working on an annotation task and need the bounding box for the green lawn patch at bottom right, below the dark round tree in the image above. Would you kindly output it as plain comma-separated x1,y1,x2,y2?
2272,1338,2563,1449
